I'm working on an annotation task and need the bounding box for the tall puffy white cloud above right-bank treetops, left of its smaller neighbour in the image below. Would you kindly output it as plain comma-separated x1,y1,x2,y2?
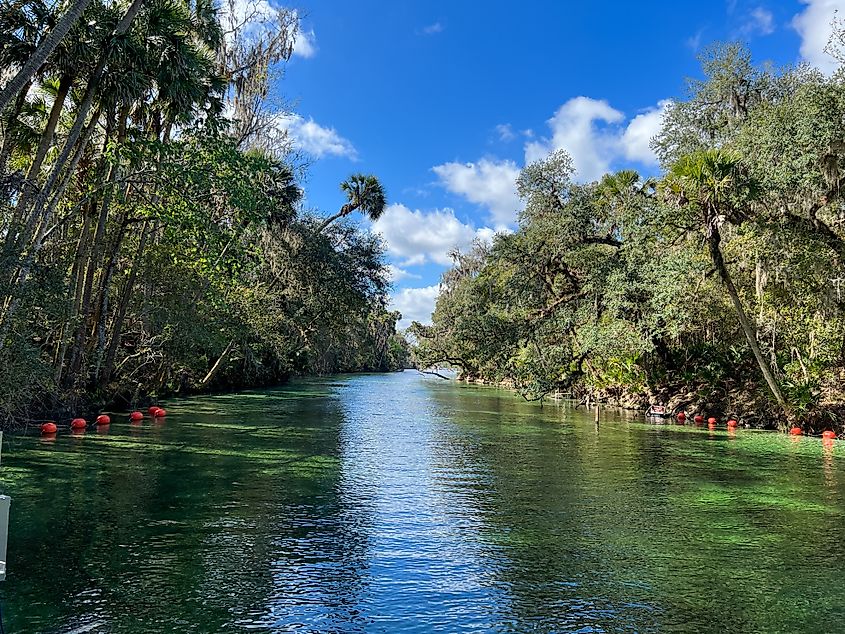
525,97,625,181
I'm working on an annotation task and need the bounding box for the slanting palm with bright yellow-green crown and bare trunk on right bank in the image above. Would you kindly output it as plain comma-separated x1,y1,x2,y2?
664,149,786,408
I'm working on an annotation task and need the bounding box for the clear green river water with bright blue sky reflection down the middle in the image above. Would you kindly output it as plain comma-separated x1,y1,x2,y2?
0,372,845,633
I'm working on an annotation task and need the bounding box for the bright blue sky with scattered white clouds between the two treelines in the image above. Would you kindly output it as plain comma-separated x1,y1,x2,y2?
274,0,845,326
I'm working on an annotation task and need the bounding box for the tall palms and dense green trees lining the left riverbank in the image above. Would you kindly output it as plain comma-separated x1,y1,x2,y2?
0,0,407,421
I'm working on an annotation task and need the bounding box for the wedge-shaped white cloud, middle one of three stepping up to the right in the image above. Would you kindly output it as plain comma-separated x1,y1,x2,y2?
431,159,522,225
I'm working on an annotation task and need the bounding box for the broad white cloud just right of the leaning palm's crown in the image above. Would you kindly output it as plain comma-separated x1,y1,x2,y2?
373,204,494,266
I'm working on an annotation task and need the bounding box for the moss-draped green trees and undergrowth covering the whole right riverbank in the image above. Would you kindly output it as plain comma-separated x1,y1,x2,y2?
410,42,845,433
